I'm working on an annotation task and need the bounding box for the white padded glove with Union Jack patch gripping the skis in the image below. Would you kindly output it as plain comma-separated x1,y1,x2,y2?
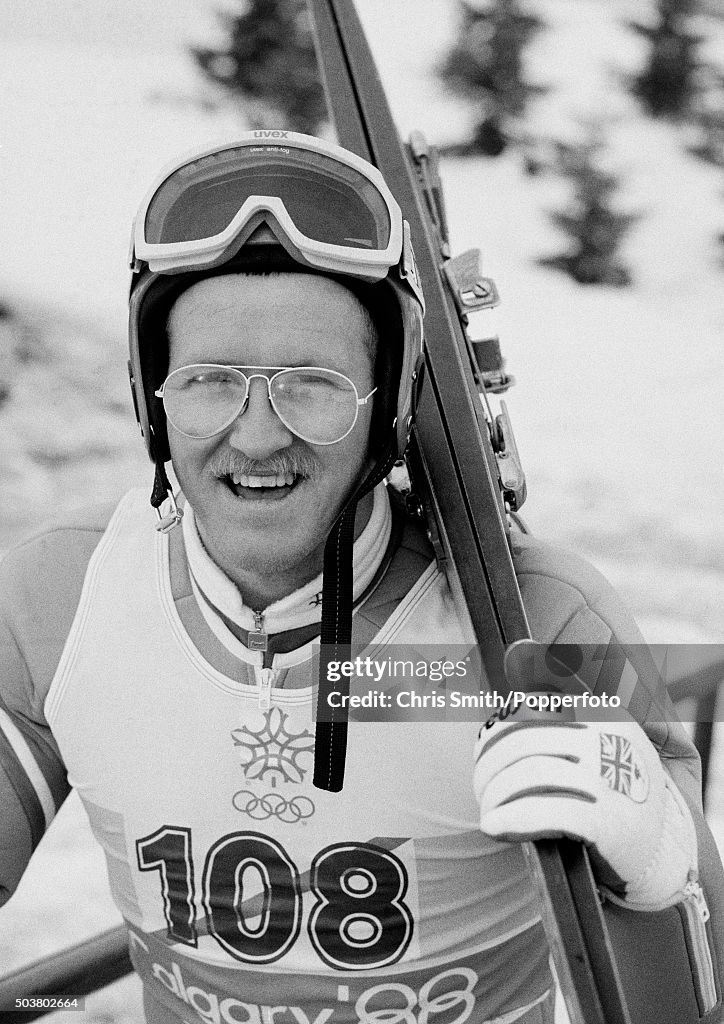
473,717,696,908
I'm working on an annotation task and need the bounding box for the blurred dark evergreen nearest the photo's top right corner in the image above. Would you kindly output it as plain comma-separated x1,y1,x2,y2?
629,0,704,118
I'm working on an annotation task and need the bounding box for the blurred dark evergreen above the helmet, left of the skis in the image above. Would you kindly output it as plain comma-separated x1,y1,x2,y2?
191,0,327,135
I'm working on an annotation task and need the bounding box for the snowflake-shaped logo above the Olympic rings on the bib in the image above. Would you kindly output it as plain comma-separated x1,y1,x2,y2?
231,708,314,786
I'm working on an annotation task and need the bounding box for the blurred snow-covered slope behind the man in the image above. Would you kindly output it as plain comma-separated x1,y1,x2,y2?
0,0,724,1024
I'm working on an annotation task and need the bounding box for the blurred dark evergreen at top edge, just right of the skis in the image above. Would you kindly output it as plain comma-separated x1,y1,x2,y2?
439,0,545,156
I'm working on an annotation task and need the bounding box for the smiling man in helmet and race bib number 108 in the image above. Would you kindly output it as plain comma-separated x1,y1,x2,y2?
0,133,721,1024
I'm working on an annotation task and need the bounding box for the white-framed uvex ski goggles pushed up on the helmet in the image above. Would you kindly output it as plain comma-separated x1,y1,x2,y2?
131,131,417,288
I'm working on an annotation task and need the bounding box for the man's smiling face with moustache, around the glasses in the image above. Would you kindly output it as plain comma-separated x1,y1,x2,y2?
168,273,374,601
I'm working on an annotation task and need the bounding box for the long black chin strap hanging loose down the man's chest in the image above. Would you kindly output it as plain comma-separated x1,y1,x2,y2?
313,439,396,793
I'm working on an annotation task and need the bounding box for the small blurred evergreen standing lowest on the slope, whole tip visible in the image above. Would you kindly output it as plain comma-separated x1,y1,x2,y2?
539,125,638,287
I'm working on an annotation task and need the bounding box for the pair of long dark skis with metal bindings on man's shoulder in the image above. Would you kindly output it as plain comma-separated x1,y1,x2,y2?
310,0,631,1024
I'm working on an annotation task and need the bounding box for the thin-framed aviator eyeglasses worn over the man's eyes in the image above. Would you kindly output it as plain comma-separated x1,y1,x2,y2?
155,362,377,444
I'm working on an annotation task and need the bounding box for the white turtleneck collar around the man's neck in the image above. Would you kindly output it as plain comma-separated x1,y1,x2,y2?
182,483,392,633
